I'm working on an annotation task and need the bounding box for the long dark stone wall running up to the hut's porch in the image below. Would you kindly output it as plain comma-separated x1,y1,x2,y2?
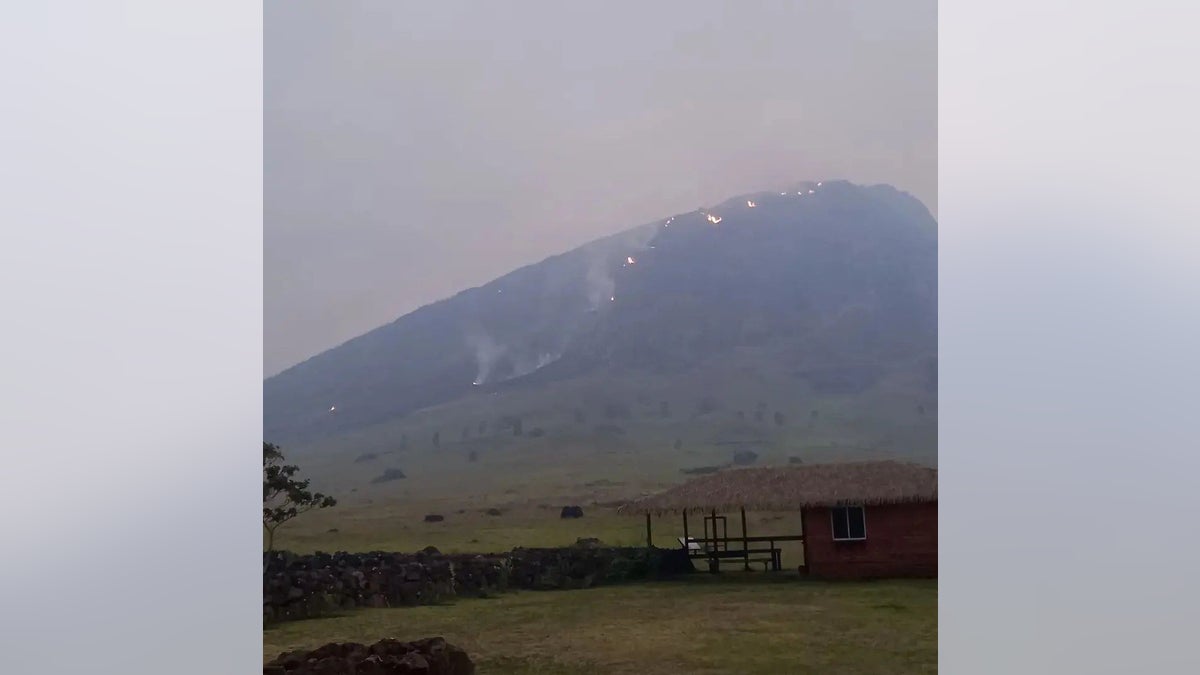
263,544,690,623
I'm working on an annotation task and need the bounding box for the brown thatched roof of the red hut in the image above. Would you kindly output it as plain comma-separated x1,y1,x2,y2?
619,461,937,515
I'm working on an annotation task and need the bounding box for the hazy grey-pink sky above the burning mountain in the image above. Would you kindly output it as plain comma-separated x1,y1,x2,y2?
263,0,937,375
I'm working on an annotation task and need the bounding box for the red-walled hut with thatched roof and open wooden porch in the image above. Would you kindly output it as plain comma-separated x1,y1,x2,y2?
622,461,937,579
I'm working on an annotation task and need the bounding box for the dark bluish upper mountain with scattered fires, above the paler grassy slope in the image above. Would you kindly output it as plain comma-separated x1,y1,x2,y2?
264,181,937,451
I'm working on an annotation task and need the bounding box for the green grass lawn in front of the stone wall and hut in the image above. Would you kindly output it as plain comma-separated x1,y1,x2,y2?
263,573,937,675
